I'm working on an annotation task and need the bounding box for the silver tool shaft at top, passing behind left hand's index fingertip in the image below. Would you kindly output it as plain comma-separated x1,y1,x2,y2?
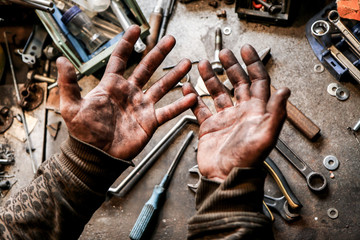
110,0,146,53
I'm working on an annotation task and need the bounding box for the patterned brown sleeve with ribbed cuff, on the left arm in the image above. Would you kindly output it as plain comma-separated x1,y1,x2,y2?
0,137,133,239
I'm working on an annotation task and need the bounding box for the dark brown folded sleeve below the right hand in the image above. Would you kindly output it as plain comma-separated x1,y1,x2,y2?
188,168,273,240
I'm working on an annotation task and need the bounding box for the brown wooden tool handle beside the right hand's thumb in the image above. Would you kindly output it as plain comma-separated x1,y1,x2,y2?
271,85,320,141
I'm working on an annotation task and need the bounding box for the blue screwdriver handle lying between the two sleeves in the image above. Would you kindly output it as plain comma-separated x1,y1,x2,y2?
129,185,165,240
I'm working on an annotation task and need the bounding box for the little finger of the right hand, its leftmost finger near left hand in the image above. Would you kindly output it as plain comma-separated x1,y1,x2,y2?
182,83,212,125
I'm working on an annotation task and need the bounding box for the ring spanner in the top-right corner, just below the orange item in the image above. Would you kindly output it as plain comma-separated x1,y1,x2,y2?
328,10,360,57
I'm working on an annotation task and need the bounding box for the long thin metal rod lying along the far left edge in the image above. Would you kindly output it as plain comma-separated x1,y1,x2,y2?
4,31,38,173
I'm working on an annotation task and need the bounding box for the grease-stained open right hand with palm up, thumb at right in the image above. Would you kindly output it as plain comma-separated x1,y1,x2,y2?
183,45,290,181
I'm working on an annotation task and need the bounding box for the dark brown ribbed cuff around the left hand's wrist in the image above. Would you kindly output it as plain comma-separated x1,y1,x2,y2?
59,136,134,193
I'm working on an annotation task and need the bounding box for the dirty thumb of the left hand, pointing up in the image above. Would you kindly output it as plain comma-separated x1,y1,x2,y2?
56,57,81,112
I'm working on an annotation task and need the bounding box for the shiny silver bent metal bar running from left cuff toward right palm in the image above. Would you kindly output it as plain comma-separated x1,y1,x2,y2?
108,115,197,195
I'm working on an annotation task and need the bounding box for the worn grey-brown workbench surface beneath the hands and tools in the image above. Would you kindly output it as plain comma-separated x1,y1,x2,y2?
1,0,360,240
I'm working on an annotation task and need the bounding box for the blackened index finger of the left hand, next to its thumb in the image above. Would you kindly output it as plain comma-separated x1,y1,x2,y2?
105,25,140,75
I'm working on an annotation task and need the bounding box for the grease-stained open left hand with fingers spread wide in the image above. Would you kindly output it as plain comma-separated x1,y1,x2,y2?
57,26,196,159
